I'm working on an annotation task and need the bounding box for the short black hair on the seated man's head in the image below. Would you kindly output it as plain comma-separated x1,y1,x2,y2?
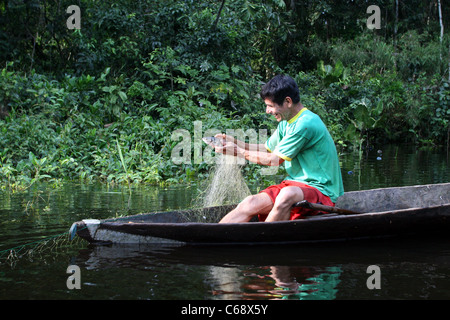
261,74,300,106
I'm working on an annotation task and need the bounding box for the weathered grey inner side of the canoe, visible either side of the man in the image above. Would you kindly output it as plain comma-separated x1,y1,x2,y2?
104,183,450,223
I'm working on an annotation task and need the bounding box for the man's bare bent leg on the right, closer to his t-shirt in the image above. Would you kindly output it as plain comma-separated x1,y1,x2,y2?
266,186,304,222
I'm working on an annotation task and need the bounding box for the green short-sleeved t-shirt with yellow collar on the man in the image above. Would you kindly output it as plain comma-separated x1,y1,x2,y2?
266,108,344,203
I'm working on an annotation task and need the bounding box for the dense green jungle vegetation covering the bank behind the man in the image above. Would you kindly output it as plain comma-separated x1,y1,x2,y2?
0,0,450,189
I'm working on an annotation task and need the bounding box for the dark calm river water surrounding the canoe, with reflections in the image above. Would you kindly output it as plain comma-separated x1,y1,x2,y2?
0,146,450,301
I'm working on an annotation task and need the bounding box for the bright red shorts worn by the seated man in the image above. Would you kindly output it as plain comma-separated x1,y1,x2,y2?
258,180,334,221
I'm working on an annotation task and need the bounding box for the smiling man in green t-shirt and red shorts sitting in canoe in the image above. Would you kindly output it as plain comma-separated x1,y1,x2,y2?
215,75,344,223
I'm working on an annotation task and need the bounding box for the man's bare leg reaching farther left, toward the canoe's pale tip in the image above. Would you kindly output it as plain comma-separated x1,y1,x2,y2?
219,192,273,223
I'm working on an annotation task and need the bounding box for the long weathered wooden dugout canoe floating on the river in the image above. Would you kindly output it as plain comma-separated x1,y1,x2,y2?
69,183,450,245
